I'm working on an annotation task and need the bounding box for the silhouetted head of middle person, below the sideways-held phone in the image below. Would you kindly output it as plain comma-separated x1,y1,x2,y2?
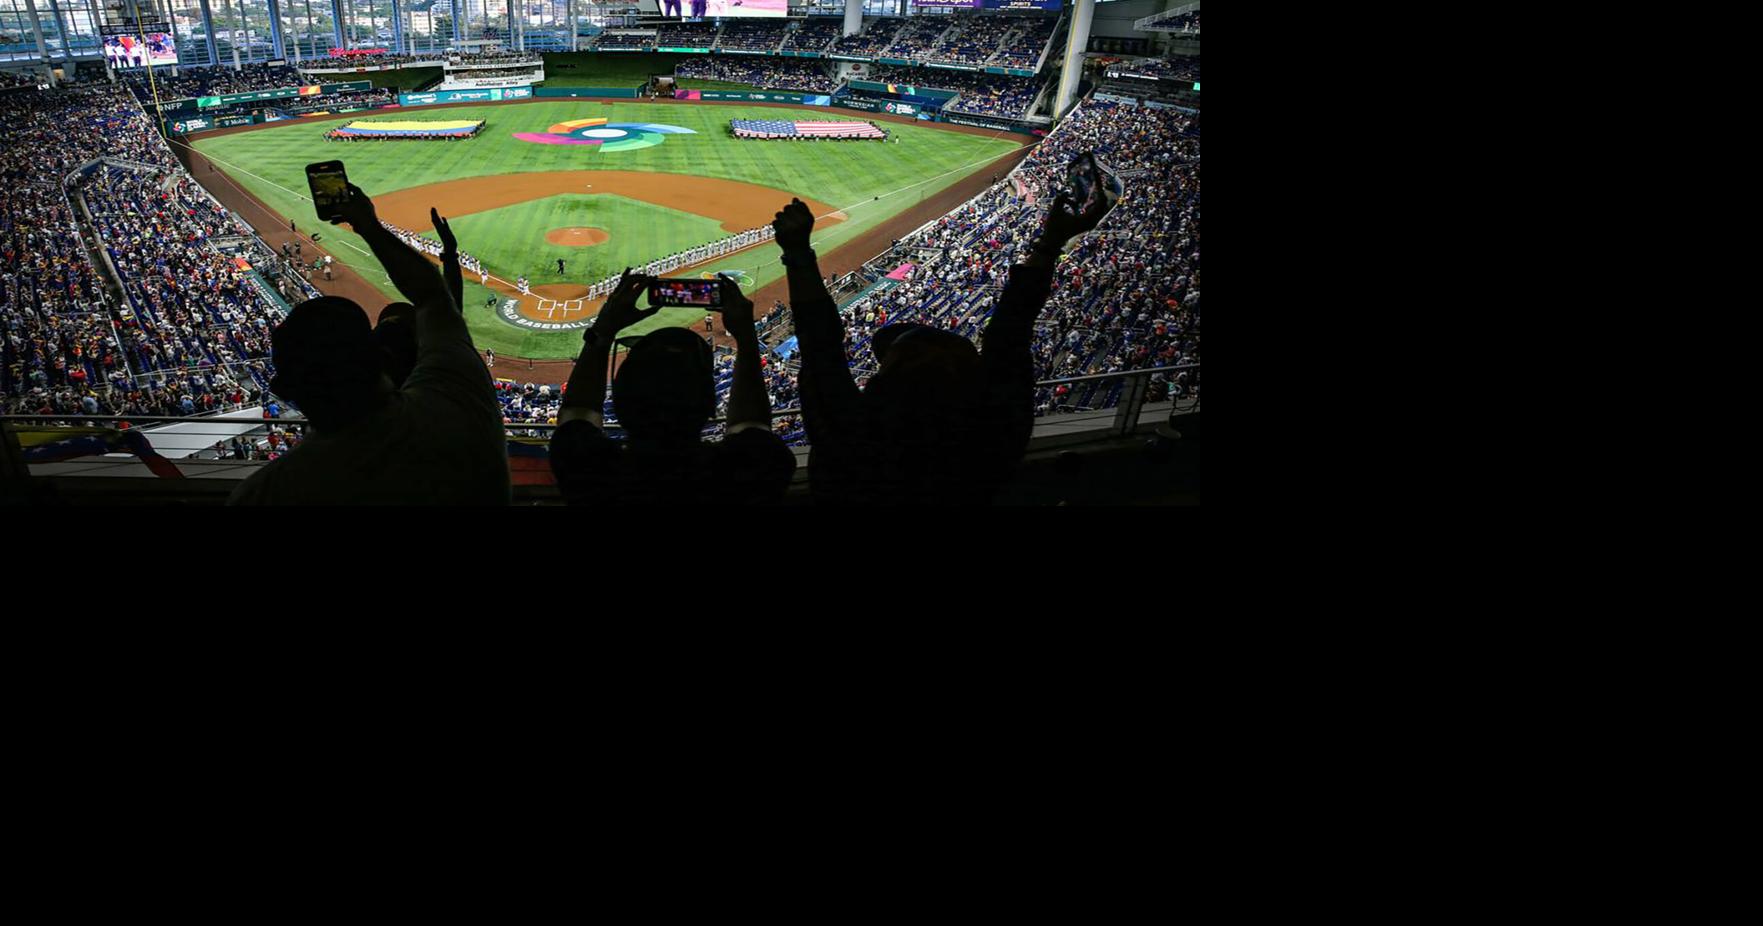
612,328,716,443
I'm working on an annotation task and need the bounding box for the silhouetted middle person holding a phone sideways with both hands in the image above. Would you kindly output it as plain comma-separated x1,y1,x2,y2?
550,268,795,504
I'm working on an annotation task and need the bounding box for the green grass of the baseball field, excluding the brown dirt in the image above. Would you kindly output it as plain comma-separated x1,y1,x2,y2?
194,101,1017,360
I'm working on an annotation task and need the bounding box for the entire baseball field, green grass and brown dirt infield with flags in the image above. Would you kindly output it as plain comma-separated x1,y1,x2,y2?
194,101,1021,360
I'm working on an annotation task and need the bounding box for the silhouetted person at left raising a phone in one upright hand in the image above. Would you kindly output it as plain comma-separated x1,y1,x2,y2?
231,185,510,504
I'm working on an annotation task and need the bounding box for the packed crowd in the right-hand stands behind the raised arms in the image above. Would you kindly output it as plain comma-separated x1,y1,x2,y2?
844,101,1201,413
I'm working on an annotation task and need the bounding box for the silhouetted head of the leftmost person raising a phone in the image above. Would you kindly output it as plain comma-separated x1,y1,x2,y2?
270,296,384,429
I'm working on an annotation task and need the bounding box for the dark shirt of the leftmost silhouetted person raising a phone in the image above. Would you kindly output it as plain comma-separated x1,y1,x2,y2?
227,305,510,504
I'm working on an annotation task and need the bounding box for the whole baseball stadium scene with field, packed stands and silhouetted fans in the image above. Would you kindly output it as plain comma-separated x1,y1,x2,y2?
0,0,1201,506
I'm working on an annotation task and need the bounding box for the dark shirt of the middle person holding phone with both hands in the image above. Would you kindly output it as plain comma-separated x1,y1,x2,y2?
550,420,795,504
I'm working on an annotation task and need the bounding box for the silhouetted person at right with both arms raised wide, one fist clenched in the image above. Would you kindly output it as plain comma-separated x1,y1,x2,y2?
774,187,1105,504
